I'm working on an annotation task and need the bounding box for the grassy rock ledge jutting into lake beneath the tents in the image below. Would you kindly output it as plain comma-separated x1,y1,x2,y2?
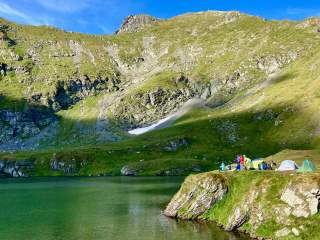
164,171,320,239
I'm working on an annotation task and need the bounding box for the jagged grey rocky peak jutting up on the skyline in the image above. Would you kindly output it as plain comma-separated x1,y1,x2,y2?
116,14,158,34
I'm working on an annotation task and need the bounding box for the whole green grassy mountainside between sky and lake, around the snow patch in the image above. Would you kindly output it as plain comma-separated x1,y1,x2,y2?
0,12,320,175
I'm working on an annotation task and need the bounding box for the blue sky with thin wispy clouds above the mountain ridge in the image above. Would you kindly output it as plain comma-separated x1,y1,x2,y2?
0,0,320,34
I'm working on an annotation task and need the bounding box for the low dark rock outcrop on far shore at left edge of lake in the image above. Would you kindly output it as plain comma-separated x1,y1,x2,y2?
0,160,34,178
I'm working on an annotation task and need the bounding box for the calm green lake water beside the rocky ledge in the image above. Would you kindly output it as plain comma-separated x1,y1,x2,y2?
0,177,250,240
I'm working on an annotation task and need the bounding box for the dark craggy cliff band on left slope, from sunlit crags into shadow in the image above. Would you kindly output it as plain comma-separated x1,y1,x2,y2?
0,74,120,145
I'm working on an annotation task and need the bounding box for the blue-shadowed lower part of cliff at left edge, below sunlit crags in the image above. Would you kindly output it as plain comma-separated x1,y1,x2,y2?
0,108,57,144
